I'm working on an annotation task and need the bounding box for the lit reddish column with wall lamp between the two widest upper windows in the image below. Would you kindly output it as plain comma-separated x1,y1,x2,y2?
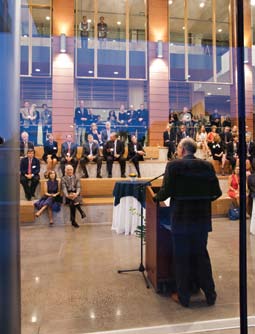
147,0,169,146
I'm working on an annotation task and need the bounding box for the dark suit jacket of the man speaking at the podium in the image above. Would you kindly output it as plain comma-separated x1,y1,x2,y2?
156,155,222,234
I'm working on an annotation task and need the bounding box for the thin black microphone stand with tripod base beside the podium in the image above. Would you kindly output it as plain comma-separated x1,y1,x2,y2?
118,173,165,289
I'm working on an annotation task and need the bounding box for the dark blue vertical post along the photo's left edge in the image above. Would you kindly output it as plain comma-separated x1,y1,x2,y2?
0,0,21,334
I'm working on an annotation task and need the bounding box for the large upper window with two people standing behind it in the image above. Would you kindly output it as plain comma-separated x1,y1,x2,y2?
75,0,146,79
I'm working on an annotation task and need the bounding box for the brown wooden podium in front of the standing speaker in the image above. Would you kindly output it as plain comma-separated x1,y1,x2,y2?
145,186,174,292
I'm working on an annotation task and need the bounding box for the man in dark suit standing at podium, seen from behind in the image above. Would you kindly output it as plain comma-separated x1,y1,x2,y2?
154,138,222,307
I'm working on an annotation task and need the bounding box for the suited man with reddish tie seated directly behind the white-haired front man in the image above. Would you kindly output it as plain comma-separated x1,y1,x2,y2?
60,134,78,175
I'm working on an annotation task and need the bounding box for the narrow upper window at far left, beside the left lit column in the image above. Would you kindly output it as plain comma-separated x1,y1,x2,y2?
20,0,51,76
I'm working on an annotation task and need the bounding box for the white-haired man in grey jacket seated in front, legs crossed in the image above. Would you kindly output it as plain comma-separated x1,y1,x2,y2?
61,165,86,228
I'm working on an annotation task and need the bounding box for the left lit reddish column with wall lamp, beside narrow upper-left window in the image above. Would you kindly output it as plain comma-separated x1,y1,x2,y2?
52,0,74,143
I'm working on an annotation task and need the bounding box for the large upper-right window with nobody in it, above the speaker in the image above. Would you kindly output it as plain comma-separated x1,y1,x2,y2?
169,0,232,83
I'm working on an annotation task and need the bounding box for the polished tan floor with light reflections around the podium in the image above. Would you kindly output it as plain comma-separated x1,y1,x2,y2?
21,218,255,334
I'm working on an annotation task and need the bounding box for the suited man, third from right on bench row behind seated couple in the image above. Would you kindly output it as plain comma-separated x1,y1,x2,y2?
80,134,103,178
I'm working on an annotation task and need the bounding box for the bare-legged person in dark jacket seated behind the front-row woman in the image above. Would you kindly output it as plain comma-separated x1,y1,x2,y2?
42,133,58,177
